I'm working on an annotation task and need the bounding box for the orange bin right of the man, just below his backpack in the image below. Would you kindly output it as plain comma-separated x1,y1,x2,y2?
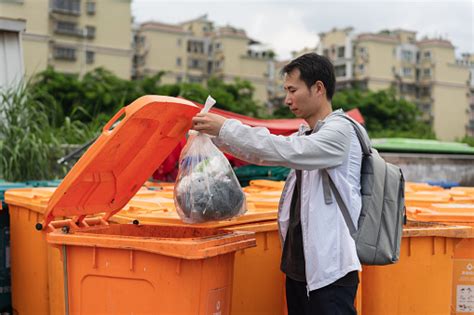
362,223,470,315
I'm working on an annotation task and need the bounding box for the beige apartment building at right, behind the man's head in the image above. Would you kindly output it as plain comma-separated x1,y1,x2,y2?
315,28,473,140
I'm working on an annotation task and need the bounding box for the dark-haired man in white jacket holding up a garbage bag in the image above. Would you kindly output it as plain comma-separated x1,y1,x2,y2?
193,53,362,315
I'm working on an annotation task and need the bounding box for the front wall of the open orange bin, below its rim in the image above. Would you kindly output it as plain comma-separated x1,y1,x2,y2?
66,246,233,315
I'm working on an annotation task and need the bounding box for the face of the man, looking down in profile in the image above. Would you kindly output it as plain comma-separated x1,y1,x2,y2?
283,69,318,119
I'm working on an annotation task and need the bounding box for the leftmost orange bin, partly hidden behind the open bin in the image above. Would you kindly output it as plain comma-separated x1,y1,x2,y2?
7,188,64,314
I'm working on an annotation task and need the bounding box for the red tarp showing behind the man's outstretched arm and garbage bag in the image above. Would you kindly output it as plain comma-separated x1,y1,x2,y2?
153,103,364,181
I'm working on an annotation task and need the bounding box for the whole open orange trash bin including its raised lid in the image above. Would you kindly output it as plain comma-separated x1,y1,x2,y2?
37,97,255,314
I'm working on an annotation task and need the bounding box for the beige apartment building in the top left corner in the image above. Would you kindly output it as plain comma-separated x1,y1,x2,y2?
0,0,132,79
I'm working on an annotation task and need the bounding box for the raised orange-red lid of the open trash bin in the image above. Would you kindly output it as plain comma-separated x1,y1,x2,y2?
43,95,199,226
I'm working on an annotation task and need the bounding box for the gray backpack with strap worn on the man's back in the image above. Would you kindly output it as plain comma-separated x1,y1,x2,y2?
322,115,406,265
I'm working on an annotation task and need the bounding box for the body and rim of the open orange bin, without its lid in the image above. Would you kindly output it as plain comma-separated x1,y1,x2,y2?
47,224,255,315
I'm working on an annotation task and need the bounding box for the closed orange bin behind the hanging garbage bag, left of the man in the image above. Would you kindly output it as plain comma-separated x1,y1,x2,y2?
110,196,284,315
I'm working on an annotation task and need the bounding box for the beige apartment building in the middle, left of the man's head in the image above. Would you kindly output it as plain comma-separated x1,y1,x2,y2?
132,15,274,103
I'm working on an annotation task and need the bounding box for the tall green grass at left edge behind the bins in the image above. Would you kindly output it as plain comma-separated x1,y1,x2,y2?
0,83,105,181
